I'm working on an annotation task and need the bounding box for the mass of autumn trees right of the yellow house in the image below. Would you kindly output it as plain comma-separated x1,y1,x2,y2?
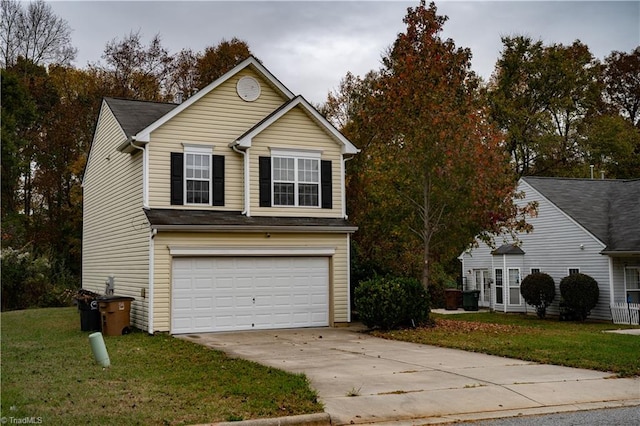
322,0,640,303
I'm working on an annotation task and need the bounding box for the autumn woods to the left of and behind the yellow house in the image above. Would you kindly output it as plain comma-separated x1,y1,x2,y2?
0,0,251,310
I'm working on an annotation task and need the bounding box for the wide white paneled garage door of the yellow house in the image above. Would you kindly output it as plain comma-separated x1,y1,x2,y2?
171,257,329,334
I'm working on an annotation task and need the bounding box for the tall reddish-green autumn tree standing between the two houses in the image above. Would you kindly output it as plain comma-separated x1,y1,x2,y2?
332,2,523,288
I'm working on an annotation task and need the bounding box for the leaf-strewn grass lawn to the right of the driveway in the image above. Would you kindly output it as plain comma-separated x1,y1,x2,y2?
374,313,640,377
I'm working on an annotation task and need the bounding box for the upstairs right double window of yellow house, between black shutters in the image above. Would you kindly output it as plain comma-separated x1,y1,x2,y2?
272,156,320,207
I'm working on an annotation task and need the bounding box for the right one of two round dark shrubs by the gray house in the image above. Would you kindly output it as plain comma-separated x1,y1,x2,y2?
560,274,600,321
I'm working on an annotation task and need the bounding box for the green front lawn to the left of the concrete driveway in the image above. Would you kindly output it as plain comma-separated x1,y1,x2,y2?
1,308,323,425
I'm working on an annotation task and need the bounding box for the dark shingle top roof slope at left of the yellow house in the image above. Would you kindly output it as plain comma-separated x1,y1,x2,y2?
104,98,178,137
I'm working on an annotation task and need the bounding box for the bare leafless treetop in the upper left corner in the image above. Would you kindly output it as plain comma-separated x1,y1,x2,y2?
0,0,77,67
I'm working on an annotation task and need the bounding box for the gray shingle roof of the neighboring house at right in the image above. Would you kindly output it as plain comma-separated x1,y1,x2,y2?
523,177,640,252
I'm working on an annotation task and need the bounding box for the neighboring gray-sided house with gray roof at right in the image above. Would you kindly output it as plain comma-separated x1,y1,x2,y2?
459,177,640,324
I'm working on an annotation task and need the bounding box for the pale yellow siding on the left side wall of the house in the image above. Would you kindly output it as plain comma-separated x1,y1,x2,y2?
82,104,149,330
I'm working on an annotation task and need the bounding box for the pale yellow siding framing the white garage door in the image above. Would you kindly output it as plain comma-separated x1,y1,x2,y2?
154,232,349,331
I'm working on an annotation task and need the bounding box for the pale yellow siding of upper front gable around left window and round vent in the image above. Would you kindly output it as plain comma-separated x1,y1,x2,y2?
148,69,286,210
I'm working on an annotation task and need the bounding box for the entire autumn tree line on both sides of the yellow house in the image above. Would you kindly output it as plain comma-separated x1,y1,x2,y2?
0,0,640,309
